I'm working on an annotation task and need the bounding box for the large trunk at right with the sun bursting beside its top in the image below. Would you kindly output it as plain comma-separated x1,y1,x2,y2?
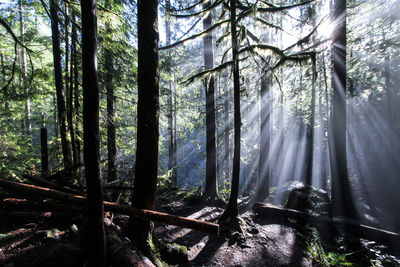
329,0,357,219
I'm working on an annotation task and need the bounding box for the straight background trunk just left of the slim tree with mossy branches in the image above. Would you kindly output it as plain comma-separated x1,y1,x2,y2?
203,1,217,197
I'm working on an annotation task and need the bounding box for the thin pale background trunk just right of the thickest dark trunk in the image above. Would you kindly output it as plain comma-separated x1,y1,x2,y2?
165,0,178,184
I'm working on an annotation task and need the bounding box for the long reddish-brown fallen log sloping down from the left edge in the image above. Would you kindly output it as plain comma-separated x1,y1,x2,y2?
0,179,219,234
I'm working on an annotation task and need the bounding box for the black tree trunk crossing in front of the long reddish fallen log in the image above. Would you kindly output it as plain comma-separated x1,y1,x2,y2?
81,0,106,266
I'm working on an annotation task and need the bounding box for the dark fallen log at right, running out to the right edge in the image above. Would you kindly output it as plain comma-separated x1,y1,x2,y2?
253,202,400,253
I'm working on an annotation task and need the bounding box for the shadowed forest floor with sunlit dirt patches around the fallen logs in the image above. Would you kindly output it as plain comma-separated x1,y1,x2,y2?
0,191,400,267
